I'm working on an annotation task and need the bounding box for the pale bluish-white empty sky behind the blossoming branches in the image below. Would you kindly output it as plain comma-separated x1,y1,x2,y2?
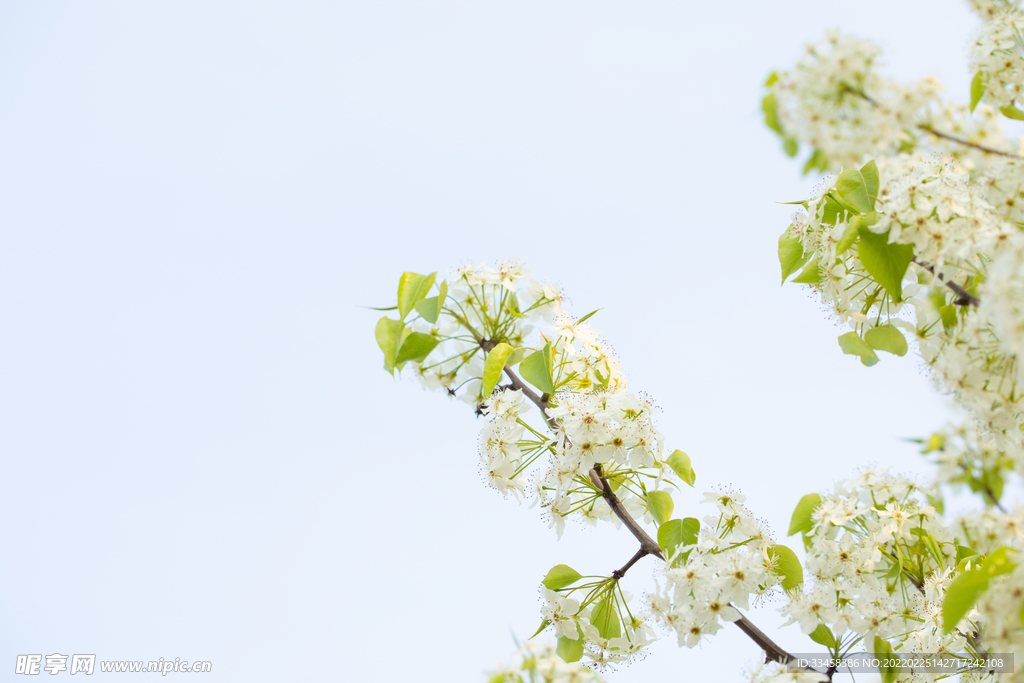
0,0,991,683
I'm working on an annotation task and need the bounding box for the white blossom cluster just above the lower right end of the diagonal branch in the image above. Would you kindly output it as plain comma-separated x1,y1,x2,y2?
644,490,779,647
